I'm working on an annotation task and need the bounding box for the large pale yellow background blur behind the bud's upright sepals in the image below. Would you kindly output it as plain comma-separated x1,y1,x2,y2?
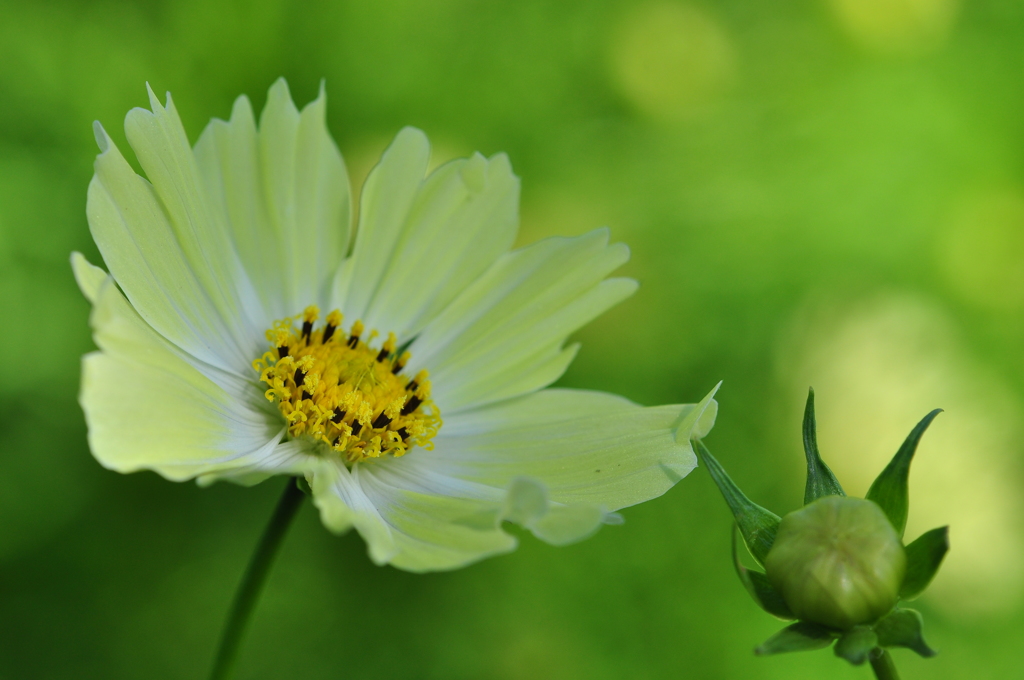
778,296,1024,615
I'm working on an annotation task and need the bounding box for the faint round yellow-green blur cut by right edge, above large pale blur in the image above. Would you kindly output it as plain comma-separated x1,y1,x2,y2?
936,188,1024,311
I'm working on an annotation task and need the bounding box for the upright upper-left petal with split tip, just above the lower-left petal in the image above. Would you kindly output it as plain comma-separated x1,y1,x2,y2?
86,86,265,373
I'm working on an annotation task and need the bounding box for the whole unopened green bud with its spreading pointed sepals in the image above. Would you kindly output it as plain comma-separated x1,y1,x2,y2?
691,390,949,667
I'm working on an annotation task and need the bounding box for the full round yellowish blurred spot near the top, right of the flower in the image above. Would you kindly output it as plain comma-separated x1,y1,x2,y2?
610,2,736,121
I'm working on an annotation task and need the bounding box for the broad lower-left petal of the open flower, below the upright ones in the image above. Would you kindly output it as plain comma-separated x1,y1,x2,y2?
79,280,308,482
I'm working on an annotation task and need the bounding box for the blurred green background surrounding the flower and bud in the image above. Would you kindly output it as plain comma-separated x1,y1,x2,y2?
0,0,1024,680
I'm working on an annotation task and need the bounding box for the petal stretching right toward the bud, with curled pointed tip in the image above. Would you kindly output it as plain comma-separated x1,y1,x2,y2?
436,389,714,510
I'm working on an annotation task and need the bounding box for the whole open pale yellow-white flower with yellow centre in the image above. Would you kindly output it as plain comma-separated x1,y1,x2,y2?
72,80,716,571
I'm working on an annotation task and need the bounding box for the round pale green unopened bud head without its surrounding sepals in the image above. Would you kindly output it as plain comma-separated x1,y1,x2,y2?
765,496,906,630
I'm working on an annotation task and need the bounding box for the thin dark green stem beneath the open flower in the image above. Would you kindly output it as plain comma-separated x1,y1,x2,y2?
210,479,305,680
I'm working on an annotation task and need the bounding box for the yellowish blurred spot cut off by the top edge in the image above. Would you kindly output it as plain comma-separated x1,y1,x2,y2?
831,0,959,54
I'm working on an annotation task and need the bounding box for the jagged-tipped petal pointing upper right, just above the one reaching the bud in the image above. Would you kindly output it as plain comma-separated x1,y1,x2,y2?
407,229,636,411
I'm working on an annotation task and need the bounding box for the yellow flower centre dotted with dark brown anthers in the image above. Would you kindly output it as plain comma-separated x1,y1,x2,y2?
253,306,441,463
